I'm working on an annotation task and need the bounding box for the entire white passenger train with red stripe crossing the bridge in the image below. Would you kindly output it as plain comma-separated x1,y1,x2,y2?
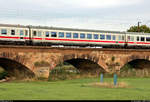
0,24,150,48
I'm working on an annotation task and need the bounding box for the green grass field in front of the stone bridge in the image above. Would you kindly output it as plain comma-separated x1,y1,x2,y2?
0,78,150,100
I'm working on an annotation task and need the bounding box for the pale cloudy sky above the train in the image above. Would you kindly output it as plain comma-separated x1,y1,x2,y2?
0,0,150,31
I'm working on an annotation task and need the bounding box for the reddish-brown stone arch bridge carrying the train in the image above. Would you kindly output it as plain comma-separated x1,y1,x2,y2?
0,46,150,77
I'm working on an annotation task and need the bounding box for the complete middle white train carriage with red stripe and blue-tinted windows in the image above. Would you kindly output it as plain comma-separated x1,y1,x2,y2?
31,26,125,46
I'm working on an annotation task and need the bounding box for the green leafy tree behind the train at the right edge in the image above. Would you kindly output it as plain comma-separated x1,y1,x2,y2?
127,25,150,33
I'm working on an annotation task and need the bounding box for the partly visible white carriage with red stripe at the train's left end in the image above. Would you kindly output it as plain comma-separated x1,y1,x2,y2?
0,24,29,44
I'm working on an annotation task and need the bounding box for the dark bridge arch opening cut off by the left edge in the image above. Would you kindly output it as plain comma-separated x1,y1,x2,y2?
0,57,35,79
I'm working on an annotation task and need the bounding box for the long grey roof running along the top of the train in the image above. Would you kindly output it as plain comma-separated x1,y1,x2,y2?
0,24,150,35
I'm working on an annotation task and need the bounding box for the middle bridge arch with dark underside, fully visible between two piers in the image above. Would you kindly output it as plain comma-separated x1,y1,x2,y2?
51,54,106,74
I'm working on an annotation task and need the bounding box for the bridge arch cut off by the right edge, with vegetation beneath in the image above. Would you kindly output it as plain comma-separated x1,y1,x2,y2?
120,59,150,77
